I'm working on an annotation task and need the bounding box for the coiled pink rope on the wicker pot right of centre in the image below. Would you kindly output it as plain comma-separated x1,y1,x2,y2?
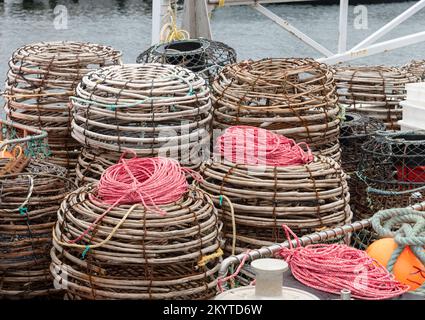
216,126,313,166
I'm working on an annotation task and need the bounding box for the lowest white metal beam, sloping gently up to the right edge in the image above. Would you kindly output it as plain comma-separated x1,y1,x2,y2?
317,31,425,64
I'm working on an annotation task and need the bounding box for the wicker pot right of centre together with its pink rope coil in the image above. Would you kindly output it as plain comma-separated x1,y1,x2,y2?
199,126,352,254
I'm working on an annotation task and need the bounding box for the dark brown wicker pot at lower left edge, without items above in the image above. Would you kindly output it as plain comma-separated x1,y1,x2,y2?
0,160,72,299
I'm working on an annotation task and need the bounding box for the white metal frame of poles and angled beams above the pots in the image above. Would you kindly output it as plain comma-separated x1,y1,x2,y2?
152,0,425,64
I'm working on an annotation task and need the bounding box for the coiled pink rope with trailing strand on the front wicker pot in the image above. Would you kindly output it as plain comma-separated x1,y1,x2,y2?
70,153,202,243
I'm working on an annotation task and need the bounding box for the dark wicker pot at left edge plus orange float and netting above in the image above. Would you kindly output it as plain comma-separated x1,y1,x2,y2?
0,121,73,299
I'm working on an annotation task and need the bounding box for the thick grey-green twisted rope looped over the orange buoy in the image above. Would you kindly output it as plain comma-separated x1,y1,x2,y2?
371,208,425,295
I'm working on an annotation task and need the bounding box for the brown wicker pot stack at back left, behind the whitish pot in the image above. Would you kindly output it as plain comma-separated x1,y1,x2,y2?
4,41,121,173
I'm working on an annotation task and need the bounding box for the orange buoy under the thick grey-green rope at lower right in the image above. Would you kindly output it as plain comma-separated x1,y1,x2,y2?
366,238,425,291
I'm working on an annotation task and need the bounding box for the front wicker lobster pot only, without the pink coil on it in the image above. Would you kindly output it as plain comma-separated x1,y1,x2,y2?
51,184,220,299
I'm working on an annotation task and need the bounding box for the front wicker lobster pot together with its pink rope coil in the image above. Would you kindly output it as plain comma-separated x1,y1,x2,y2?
51,157,222,300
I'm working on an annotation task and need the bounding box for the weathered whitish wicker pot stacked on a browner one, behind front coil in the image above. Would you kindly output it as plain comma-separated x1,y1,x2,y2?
72,64,212,184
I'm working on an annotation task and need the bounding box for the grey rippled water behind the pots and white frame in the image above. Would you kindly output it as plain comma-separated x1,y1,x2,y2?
0,0,425,109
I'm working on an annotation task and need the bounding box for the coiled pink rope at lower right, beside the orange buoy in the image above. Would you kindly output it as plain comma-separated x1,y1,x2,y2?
278,225,409,300
